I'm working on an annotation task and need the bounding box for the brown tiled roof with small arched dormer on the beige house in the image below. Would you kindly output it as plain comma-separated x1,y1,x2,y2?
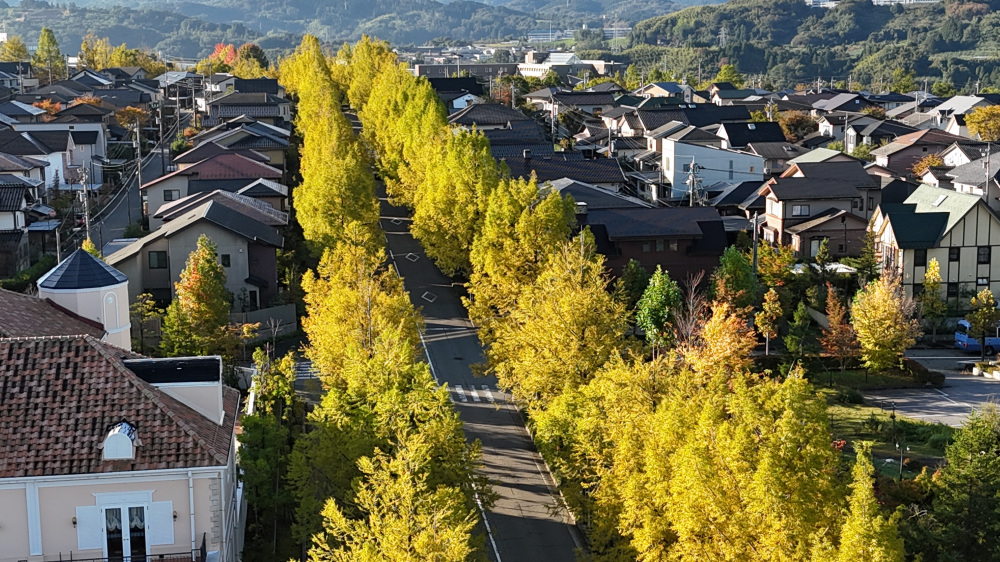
0,336,240,478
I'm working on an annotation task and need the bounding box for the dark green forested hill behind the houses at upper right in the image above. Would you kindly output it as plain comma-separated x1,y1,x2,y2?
626,0,1000,91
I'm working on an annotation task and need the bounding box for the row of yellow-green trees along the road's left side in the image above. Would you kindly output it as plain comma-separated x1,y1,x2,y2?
280,36,488,561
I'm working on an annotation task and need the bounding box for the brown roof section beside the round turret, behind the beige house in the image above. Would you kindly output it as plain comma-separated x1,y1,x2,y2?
0,289,104,339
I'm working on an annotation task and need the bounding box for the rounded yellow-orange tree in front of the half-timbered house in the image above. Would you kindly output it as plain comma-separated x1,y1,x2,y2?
851,275,920,371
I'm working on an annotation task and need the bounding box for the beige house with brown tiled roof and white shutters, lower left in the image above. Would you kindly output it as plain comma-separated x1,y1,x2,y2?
0,335,244,562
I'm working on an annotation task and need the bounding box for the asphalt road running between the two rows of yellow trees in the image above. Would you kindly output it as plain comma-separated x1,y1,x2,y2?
381,188,583,562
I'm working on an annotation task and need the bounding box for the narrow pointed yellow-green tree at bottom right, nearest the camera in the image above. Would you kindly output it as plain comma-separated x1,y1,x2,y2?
837,442,903,562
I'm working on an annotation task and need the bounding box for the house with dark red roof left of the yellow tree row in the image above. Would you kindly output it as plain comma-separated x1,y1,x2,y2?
141,149,282,229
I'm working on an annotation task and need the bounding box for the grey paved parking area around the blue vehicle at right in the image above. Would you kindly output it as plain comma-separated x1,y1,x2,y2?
865,349,1000,427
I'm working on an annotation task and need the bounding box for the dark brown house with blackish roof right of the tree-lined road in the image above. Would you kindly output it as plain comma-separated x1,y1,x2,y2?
577,206,728,279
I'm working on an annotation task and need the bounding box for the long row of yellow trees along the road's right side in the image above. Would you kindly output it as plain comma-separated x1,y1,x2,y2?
334,39,916,561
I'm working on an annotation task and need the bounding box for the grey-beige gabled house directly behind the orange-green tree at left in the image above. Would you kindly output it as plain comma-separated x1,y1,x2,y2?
105,197,287,306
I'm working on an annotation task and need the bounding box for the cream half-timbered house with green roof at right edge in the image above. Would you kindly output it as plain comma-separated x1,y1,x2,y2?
872,185,1000,302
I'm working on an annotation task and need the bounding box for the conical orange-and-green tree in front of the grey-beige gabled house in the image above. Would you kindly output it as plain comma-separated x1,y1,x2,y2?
160,234,232,357
